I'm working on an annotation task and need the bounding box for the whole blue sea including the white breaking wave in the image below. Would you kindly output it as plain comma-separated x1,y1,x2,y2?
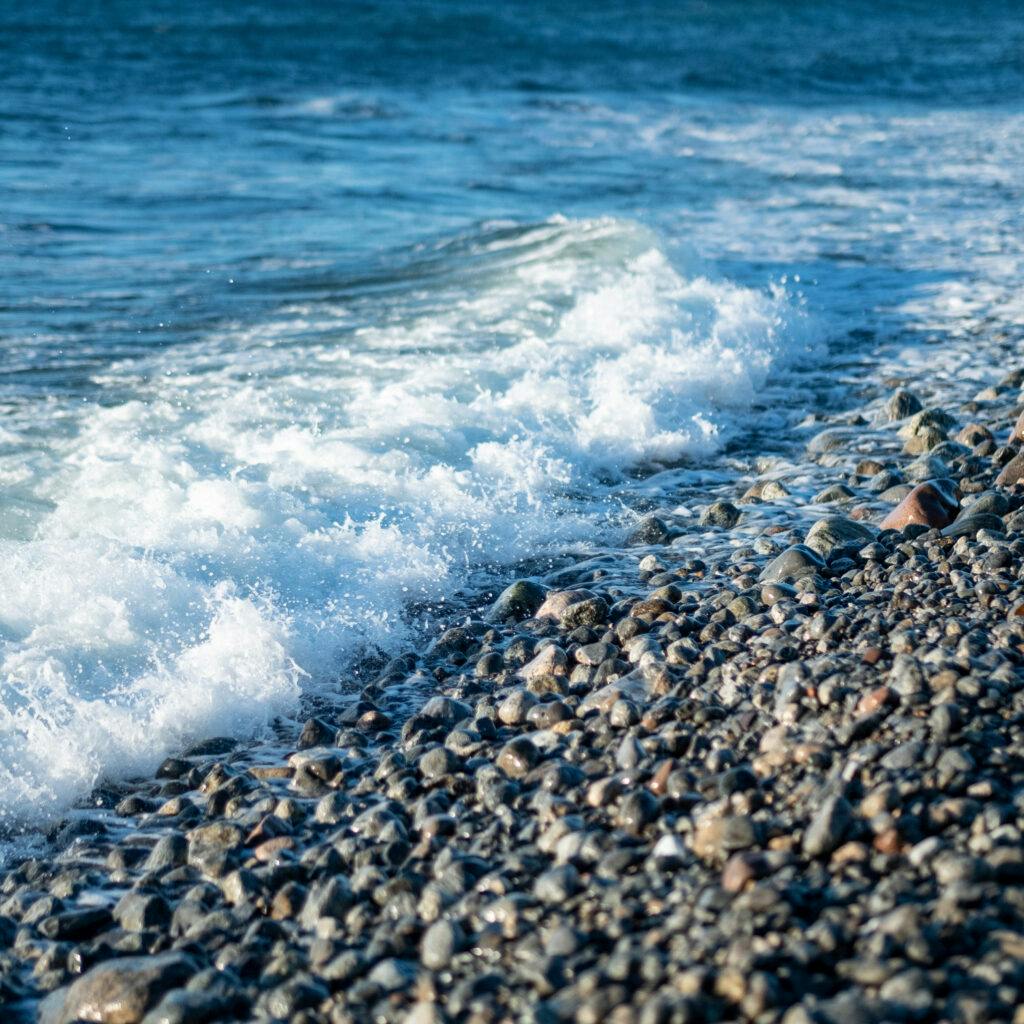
0,0,1024,834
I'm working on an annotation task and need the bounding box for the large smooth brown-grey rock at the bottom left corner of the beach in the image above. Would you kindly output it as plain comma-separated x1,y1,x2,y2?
39,953,198,1024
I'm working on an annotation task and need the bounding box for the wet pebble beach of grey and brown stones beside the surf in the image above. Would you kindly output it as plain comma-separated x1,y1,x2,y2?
6,356,1024,1024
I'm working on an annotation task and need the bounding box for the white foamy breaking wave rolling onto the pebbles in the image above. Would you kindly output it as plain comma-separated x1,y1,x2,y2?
0,218,809,821
